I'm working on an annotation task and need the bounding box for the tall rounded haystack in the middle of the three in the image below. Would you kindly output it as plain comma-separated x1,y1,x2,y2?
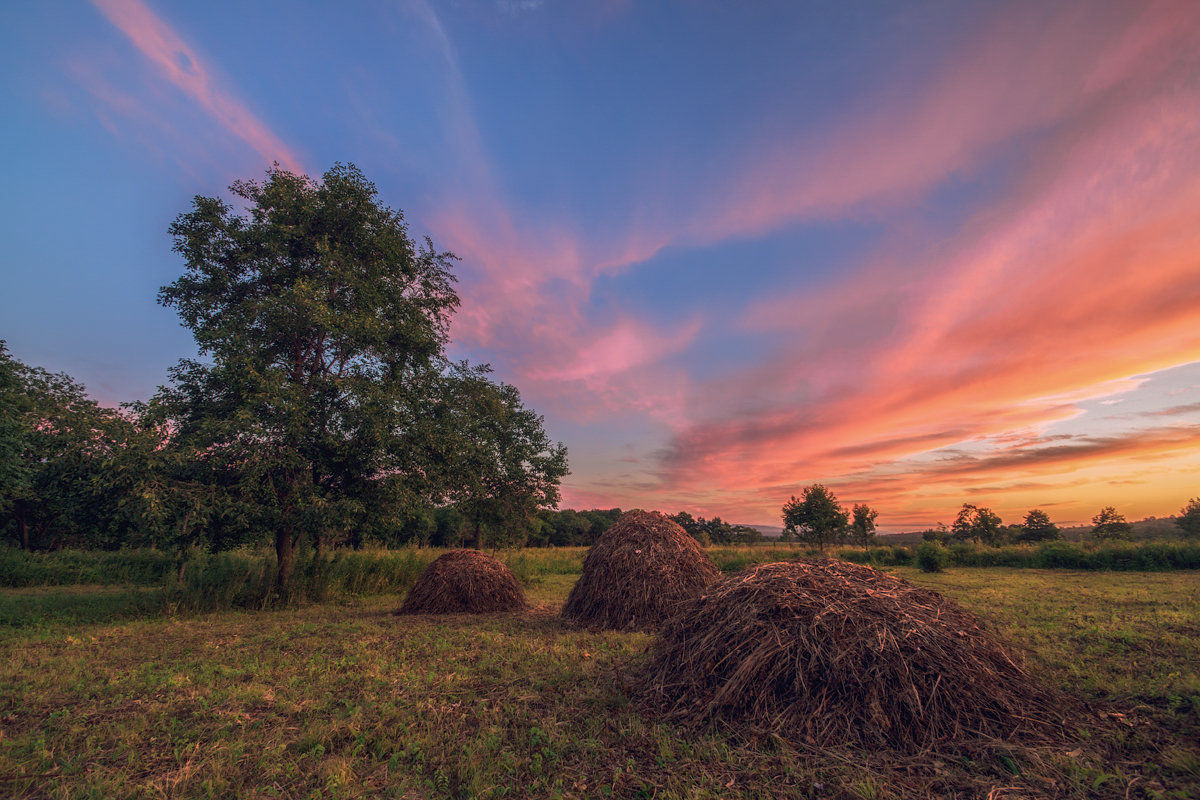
563,511,721,631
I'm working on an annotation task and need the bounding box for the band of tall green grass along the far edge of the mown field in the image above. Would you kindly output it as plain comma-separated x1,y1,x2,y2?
0,541,1200,612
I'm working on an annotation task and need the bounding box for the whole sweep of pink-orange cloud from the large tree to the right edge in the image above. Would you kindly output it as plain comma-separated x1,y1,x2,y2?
350,1,1200,524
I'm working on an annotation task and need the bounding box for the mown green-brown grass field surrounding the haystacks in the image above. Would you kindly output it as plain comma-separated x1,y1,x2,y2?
0,563,1200,799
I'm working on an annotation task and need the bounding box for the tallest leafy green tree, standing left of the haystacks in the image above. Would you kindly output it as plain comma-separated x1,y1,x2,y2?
151,164,458,585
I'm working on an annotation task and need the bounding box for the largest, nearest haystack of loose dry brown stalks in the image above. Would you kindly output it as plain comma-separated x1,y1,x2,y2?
642,560,1067,752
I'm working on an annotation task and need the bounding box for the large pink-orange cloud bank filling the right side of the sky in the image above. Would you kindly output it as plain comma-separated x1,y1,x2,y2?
559,4,1200,523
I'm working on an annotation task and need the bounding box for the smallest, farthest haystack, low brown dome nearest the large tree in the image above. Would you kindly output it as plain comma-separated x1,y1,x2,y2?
400,551,526,614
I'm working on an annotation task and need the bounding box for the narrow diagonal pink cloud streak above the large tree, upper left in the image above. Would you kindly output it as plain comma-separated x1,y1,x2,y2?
85,0,302,172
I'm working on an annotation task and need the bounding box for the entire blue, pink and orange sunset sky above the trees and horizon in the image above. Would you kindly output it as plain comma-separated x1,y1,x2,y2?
0,0,1200,530
